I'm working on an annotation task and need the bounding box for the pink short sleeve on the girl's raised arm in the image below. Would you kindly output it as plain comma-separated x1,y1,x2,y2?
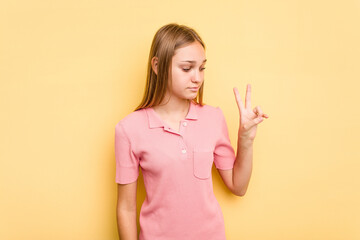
214,107,235,170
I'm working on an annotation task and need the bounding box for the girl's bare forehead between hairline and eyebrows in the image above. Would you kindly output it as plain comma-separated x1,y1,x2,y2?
173,41,206,63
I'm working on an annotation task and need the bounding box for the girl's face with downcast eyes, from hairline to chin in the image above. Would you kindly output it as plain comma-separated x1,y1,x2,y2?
168,41,206,99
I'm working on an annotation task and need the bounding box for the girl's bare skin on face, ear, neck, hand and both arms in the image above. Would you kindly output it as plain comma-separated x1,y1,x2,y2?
117,42,269,240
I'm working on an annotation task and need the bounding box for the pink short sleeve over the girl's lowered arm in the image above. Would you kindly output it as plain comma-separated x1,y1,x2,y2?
115,122,139,184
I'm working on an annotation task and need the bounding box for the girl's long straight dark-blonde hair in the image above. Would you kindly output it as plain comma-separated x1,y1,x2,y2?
135,23,205,111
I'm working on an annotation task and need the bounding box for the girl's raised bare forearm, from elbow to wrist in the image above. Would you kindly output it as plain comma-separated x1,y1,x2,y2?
233,134,253,196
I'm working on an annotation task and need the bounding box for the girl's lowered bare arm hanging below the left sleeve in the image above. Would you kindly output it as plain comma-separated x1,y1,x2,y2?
116,181,137,240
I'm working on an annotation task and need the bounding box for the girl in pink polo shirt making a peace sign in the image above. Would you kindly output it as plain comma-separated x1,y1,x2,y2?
115,24,268,240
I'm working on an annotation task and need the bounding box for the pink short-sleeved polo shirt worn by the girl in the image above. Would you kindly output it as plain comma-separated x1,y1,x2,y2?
115,102,235,240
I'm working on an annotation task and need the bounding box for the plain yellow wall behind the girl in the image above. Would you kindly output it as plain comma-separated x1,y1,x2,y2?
0,0,360,240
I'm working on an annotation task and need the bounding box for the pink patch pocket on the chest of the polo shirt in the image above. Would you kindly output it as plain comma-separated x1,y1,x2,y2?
194,149,214,179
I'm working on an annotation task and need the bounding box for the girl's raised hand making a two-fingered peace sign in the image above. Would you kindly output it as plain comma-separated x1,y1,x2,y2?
234,84,269,141
